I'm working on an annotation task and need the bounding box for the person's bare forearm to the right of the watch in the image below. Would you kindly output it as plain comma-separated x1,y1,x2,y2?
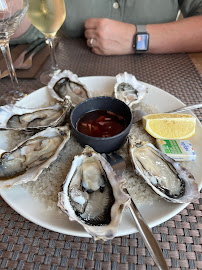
147,16,202,53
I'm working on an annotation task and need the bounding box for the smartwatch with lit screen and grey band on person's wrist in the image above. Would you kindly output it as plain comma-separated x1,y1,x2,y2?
133,25,149,53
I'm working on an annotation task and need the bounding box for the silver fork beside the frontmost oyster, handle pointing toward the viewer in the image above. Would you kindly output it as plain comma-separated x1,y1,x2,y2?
104,152,168,270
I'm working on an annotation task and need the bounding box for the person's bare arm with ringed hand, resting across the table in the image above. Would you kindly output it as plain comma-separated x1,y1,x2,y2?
85,16,202,55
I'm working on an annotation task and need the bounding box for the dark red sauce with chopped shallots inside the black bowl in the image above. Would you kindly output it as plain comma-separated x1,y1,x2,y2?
77,110,126,137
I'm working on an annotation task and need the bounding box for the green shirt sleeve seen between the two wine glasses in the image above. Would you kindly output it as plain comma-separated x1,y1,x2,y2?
10,25,44,45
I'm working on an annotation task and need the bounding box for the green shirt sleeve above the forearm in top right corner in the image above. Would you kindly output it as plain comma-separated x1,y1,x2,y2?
178,0,202,17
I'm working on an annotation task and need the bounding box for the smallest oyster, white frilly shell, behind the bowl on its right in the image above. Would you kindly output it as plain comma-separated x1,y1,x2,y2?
114,72,147,108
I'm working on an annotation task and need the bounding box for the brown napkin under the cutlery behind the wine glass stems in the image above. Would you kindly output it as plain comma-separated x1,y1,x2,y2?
0,44,50,80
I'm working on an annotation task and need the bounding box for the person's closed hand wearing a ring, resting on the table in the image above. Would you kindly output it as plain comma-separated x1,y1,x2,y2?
85,18,136,55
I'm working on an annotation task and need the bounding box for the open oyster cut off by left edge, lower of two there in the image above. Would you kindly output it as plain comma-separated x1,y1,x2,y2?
0,126,70,189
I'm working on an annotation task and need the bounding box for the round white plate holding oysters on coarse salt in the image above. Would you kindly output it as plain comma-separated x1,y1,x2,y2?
0,76,202,237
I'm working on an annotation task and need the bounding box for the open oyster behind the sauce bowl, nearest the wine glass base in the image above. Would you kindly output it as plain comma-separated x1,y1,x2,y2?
48,70,89,106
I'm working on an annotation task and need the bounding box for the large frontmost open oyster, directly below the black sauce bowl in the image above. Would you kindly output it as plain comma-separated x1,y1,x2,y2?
58,146,129,240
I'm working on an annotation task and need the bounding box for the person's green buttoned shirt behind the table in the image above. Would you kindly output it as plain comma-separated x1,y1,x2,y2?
12,0,202,44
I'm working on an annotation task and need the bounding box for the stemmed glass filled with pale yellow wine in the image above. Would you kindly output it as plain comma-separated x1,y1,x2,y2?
28,0,66,84
